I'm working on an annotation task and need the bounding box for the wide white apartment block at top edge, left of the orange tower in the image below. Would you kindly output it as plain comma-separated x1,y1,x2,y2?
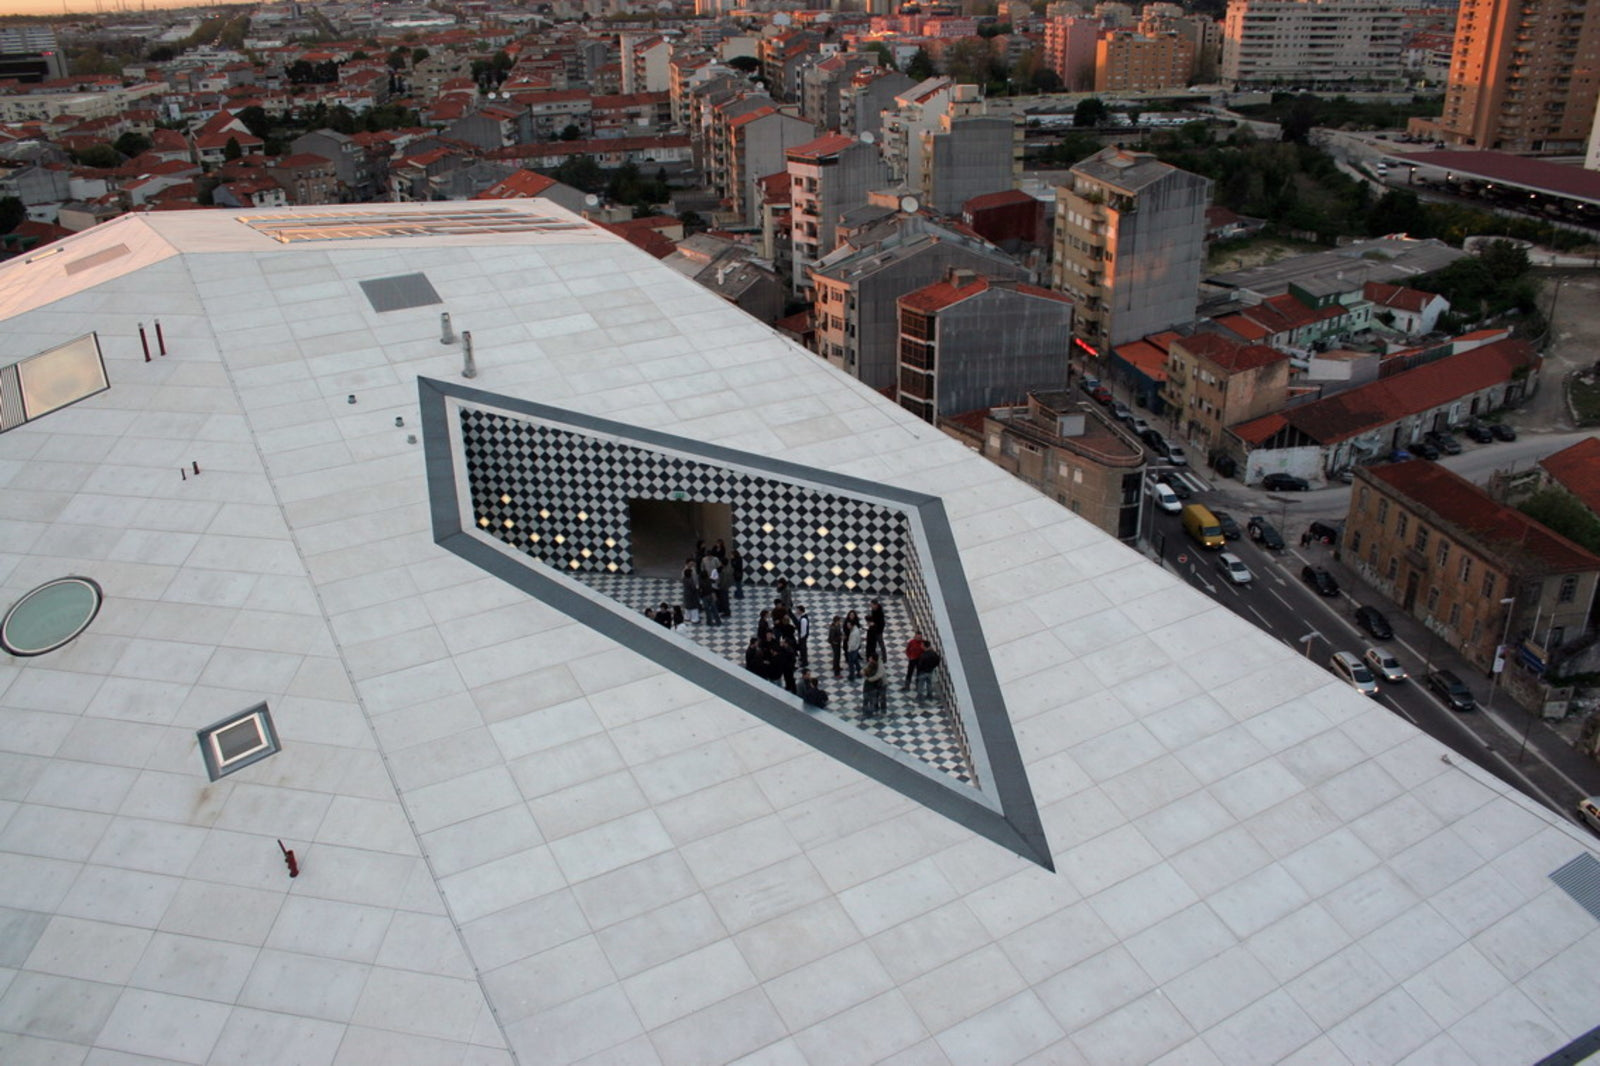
1222,0,1405,90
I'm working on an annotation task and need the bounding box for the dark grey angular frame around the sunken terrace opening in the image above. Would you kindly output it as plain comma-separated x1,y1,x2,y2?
418,376,1054,871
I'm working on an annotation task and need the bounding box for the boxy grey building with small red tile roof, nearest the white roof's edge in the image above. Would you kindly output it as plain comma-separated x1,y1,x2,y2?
896,271,1072,424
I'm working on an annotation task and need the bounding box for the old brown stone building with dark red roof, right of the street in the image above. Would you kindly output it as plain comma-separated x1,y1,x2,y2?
1342,459,1600,671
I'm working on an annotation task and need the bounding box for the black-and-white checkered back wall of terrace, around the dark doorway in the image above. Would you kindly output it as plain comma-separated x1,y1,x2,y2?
461,407,922,594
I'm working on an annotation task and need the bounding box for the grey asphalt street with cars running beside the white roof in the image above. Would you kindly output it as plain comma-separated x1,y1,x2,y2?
1147,473,1600,821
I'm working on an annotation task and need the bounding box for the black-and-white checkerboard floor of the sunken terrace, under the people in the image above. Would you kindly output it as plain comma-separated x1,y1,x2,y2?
571,573,973,781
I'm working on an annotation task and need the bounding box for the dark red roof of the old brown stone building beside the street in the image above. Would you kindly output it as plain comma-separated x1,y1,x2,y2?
1360,459,1600,573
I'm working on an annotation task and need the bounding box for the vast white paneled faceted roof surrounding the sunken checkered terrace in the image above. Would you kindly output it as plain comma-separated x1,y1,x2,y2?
0,202,1600,1066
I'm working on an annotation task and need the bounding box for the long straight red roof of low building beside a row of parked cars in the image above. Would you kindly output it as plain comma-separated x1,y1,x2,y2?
1283,341,1539,445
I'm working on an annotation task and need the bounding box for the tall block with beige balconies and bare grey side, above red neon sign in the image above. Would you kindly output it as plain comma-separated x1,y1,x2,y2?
1053,147,1211,352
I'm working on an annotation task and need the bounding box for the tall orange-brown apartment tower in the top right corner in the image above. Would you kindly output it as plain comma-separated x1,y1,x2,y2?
1432,0,1600,154
